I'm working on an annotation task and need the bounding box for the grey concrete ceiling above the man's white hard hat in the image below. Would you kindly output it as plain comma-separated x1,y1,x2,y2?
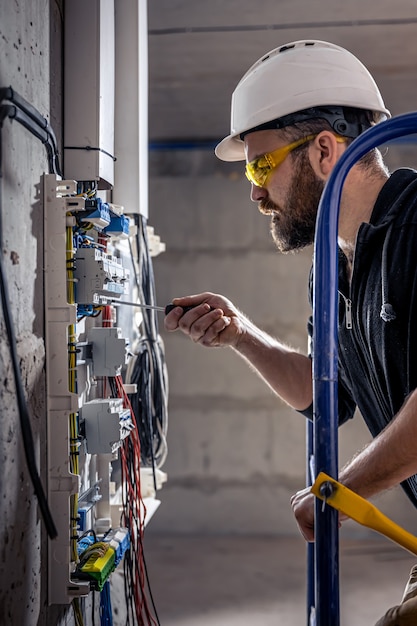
148,0,417,143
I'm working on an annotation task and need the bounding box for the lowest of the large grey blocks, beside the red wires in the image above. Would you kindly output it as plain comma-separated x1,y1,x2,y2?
81,398,134,454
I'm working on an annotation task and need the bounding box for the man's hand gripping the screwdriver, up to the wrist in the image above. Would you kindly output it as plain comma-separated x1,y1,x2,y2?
164,292,243,347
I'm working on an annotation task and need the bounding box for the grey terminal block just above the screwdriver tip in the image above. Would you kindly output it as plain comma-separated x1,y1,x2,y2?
74,246,130,305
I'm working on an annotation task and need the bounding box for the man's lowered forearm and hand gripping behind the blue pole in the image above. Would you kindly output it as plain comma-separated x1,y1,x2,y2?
291,390,417,541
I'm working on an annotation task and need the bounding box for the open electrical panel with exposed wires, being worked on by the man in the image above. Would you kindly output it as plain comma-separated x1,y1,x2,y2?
43,174,167,604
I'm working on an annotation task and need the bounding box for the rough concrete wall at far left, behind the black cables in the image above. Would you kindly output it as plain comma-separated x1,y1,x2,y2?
0,0,73,626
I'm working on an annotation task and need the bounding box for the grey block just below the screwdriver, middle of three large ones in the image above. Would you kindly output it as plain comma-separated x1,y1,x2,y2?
88,326,128,376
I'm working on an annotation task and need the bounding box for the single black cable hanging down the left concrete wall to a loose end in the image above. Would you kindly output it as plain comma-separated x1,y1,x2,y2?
0,123,58,539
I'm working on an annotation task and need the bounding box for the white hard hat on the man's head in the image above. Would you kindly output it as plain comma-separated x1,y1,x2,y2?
215,40,390,161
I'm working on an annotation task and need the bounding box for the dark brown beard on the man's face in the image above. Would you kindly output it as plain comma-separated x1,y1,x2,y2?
259,154,324,253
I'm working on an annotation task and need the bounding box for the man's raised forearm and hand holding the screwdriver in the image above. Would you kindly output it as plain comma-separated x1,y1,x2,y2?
165,292,312,410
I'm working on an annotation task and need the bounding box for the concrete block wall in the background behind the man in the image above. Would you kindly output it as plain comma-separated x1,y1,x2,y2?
149,151,415,535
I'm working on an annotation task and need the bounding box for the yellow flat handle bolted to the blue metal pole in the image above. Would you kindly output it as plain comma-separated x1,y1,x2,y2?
311,472,417,554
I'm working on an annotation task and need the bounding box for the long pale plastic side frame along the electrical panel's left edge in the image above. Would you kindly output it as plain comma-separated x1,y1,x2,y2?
43,174,90,604
